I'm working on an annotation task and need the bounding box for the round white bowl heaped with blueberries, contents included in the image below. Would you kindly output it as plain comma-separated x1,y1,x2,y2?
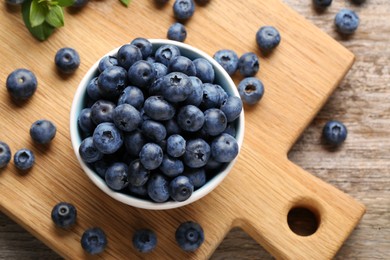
70,37,244,210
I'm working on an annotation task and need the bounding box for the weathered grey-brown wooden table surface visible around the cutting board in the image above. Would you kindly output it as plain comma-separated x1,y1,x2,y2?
0,0,390,259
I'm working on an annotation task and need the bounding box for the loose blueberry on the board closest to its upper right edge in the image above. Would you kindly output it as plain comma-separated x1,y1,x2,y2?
256,26,280,53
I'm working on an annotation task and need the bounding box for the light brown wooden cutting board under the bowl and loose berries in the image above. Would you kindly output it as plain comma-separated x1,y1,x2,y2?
0,0,365,259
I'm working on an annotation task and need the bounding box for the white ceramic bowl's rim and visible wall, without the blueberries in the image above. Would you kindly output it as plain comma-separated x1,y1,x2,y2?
70,39,244,210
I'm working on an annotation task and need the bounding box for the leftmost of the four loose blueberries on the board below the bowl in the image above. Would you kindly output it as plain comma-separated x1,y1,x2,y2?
51,202,77,228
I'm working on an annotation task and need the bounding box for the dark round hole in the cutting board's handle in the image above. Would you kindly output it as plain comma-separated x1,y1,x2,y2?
287,206,320,236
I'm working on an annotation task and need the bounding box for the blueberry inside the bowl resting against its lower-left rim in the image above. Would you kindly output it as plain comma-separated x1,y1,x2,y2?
105,162,129,190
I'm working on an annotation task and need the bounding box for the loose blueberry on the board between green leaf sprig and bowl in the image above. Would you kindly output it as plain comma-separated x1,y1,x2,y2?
54,47,80,74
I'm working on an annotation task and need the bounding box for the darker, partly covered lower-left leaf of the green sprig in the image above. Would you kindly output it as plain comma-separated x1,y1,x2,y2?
22,0,54,41
